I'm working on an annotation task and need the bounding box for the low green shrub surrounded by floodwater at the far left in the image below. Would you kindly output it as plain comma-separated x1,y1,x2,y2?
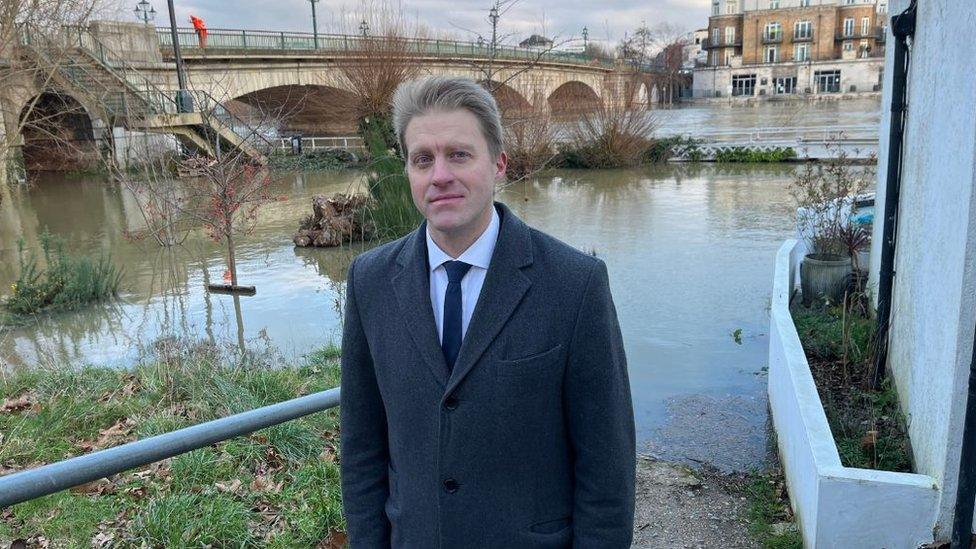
4,230,122,315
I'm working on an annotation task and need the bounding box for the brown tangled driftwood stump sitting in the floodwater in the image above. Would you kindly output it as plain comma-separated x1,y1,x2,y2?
292,193,372,247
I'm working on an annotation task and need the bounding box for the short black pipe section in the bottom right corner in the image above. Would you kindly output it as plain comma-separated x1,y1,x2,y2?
950,318,976,549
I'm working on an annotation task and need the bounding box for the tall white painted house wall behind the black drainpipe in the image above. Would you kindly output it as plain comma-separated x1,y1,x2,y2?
871,0,976,539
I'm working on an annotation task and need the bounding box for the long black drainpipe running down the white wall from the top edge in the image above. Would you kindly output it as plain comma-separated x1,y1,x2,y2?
872,0,917,389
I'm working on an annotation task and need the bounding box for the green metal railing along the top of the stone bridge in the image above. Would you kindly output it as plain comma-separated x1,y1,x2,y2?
156,27,615,67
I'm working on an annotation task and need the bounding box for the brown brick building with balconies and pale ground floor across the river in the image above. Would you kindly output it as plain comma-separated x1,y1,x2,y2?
693,0,888,98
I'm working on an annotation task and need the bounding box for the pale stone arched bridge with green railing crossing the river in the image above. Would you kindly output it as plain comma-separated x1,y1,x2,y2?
0,22,663,168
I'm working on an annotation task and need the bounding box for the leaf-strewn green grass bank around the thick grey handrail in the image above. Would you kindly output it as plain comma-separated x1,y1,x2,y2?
0,340,345,547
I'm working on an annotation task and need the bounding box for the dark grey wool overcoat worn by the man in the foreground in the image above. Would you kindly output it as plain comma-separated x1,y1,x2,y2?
340,203,636,549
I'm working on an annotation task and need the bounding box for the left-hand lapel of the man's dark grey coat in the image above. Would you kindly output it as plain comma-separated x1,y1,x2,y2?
393,223,452,387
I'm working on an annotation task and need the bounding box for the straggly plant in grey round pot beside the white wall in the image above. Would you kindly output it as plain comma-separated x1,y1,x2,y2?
790,150,874,307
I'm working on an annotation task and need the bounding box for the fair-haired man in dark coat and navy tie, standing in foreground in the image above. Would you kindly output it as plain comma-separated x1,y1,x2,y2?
340,78,636,549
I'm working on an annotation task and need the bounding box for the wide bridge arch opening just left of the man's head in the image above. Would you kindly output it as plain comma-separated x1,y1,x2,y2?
234,84,357,136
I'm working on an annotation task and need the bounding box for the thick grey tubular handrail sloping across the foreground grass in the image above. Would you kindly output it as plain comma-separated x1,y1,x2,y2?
0,387,339,508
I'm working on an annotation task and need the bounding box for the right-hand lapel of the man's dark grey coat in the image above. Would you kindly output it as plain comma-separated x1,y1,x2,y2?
444,202,532,398
